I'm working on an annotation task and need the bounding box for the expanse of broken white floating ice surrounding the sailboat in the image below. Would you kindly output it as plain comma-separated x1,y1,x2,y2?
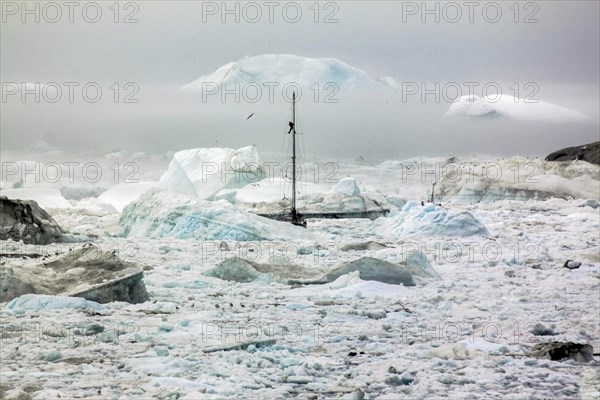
0,147,600,399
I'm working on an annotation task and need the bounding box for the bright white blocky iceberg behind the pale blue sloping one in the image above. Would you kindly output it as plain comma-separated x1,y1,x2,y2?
159,146,264,199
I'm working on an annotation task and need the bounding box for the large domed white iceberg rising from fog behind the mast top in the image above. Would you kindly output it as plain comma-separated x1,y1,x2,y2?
181,54,394,92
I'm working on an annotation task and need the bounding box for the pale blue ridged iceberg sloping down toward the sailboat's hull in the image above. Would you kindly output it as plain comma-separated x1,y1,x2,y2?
120,189,312,241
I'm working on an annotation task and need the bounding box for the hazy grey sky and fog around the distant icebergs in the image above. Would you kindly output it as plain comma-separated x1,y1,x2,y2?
0,1,600,159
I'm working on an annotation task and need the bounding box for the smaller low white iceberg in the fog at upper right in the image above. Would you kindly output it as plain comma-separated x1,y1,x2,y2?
446,94,590,122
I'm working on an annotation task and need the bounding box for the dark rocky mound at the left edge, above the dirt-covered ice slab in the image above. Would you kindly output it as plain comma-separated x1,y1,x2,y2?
0,196,65,244
